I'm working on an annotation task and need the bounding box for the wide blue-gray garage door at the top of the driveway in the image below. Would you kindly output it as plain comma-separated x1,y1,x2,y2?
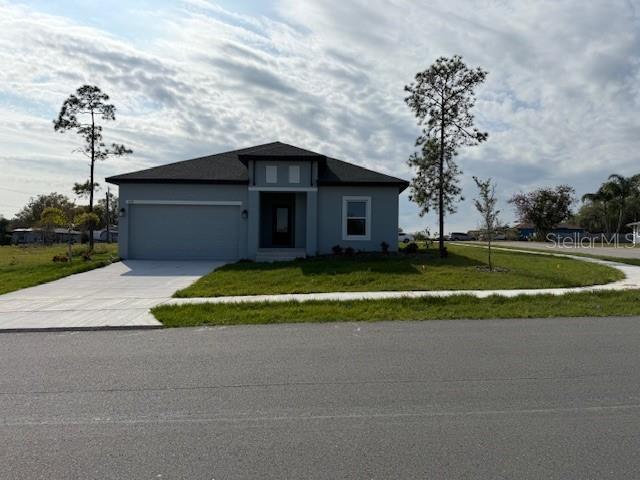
129,204,240,260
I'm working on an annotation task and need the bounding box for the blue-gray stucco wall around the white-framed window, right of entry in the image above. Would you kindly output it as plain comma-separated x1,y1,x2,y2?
318,186,398,254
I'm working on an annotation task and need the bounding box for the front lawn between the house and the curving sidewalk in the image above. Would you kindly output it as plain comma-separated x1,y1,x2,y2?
174,245,623,297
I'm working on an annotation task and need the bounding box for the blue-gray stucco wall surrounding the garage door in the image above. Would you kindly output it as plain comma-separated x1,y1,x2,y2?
118,183,248,259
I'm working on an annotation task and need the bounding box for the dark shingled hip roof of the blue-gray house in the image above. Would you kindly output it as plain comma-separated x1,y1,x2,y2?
107,142,409,191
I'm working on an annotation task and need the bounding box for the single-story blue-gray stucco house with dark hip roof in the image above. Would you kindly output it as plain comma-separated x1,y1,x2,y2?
107,142,408,261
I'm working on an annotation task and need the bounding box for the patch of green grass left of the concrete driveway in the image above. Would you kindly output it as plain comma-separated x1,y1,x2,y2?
0,244,117,294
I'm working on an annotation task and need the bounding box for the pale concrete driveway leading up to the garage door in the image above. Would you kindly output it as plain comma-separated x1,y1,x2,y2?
0,260,225,331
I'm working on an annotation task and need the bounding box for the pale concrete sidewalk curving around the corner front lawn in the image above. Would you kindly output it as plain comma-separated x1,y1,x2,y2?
162,243,640,305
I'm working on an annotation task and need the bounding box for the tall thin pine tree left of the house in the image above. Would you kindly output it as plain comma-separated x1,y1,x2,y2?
53,85,133,249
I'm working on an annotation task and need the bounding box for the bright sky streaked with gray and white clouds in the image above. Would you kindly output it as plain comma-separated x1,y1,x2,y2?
0,0,640,232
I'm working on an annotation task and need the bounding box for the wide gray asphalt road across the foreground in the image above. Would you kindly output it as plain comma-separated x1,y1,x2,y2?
0,318,640,480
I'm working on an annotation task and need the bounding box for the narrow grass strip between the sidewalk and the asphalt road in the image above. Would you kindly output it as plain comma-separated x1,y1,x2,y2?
151,290,640,327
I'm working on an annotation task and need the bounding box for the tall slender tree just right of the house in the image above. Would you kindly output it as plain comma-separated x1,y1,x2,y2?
405,55,489,257
